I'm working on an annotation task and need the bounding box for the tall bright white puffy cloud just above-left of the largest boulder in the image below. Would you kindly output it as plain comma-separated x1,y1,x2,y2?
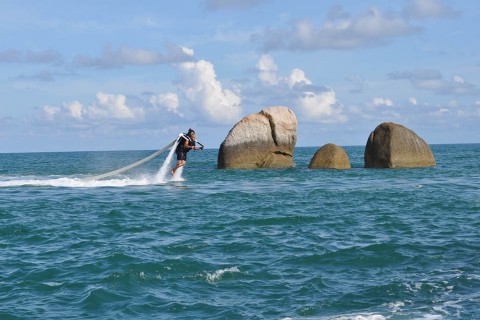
178,60,242,124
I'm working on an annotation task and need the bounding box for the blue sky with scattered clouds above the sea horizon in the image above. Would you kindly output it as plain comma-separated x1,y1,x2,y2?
0,0,480,152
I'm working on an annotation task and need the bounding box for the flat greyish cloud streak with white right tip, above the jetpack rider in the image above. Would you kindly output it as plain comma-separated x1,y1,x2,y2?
73,45,194,69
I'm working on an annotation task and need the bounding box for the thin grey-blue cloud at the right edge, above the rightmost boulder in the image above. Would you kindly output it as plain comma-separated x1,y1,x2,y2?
387,70,480,95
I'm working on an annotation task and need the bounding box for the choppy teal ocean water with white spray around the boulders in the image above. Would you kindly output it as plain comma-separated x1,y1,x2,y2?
0,144,480,320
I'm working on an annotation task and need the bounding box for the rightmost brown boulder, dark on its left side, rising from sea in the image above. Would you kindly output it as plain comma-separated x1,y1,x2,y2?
364,122,435,168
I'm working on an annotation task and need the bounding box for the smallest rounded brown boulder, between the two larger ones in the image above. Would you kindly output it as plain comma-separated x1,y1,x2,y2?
308,143,351,169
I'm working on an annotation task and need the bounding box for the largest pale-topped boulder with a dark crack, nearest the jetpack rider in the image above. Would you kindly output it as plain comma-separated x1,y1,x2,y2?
218,107,297,169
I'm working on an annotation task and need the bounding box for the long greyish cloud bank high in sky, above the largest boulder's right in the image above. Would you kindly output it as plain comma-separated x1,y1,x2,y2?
252,7,419,51
